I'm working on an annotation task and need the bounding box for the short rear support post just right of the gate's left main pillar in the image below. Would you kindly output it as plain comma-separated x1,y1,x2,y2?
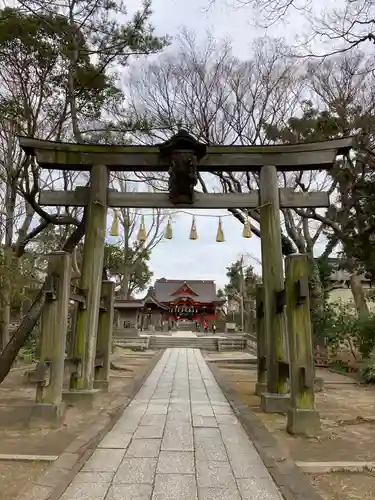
94,281,115,391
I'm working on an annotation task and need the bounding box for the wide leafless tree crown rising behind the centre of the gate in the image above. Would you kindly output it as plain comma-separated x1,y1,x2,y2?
126,32,303,252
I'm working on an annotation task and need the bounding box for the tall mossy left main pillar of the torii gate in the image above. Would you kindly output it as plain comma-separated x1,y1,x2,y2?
70,165,109,390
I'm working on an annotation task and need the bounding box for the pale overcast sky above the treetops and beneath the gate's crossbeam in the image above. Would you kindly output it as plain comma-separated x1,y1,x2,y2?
114,0,326,287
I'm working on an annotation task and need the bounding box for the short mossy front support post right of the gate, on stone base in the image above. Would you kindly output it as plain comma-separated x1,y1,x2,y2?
285,255,320,435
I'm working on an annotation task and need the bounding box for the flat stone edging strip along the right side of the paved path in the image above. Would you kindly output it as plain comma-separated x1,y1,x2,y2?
207,363,323,500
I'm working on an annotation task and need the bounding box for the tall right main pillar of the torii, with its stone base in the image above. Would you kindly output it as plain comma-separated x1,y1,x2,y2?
259,165,289,413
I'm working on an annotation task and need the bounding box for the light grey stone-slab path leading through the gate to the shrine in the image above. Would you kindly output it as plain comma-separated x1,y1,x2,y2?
61,349,282,500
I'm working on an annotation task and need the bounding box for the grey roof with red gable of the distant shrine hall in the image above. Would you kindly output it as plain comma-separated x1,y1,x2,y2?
154,278,223,303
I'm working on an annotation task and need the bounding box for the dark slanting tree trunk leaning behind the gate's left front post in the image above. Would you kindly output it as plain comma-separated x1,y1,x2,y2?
0,215,86,383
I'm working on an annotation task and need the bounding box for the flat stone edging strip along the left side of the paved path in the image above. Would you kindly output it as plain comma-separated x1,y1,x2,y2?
16,349,165,500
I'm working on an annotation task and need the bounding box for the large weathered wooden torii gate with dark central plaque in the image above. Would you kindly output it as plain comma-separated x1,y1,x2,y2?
20,131,354,410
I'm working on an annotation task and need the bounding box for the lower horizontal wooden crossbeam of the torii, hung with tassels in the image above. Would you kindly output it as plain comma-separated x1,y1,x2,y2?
39,188,329,209
